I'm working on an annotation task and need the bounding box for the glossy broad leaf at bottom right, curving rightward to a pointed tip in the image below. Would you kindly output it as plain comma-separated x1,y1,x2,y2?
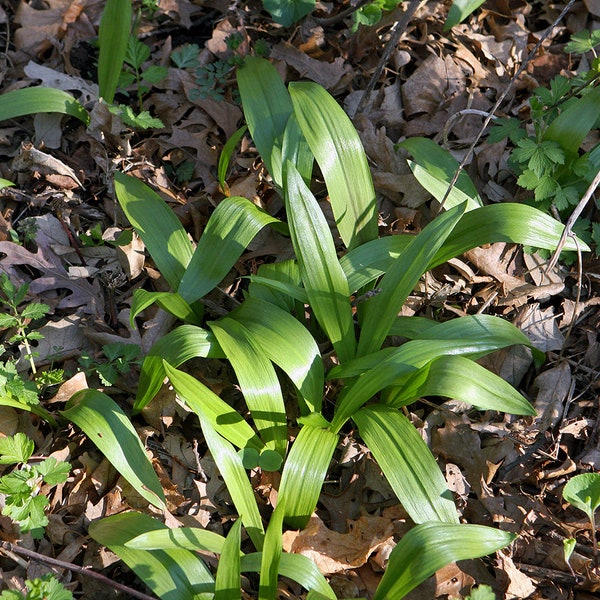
373,522,516,600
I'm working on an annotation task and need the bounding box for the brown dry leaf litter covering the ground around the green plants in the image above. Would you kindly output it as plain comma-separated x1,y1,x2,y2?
0,0,600,600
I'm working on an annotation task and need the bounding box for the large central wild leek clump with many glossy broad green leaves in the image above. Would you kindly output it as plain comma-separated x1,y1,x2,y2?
90,58,592,600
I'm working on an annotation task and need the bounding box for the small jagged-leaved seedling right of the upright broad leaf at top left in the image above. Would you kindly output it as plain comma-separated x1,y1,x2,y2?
109,35,167,129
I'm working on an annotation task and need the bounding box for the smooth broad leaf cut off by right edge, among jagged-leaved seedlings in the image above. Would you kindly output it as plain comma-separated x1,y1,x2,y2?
544,87,600,157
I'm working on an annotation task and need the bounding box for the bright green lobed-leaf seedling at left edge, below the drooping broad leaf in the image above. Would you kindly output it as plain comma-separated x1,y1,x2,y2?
0,433,71,538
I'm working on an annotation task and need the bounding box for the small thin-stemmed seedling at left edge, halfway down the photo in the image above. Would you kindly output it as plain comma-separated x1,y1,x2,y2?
0,273,50,373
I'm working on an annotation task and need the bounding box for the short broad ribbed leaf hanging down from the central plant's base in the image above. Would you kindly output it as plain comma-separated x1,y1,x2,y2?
278,425,338,529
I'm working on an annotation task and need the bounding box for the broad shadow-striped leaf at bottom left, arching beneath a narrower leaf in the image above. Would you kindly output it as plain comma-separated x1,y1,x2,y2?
89,512,214,600
